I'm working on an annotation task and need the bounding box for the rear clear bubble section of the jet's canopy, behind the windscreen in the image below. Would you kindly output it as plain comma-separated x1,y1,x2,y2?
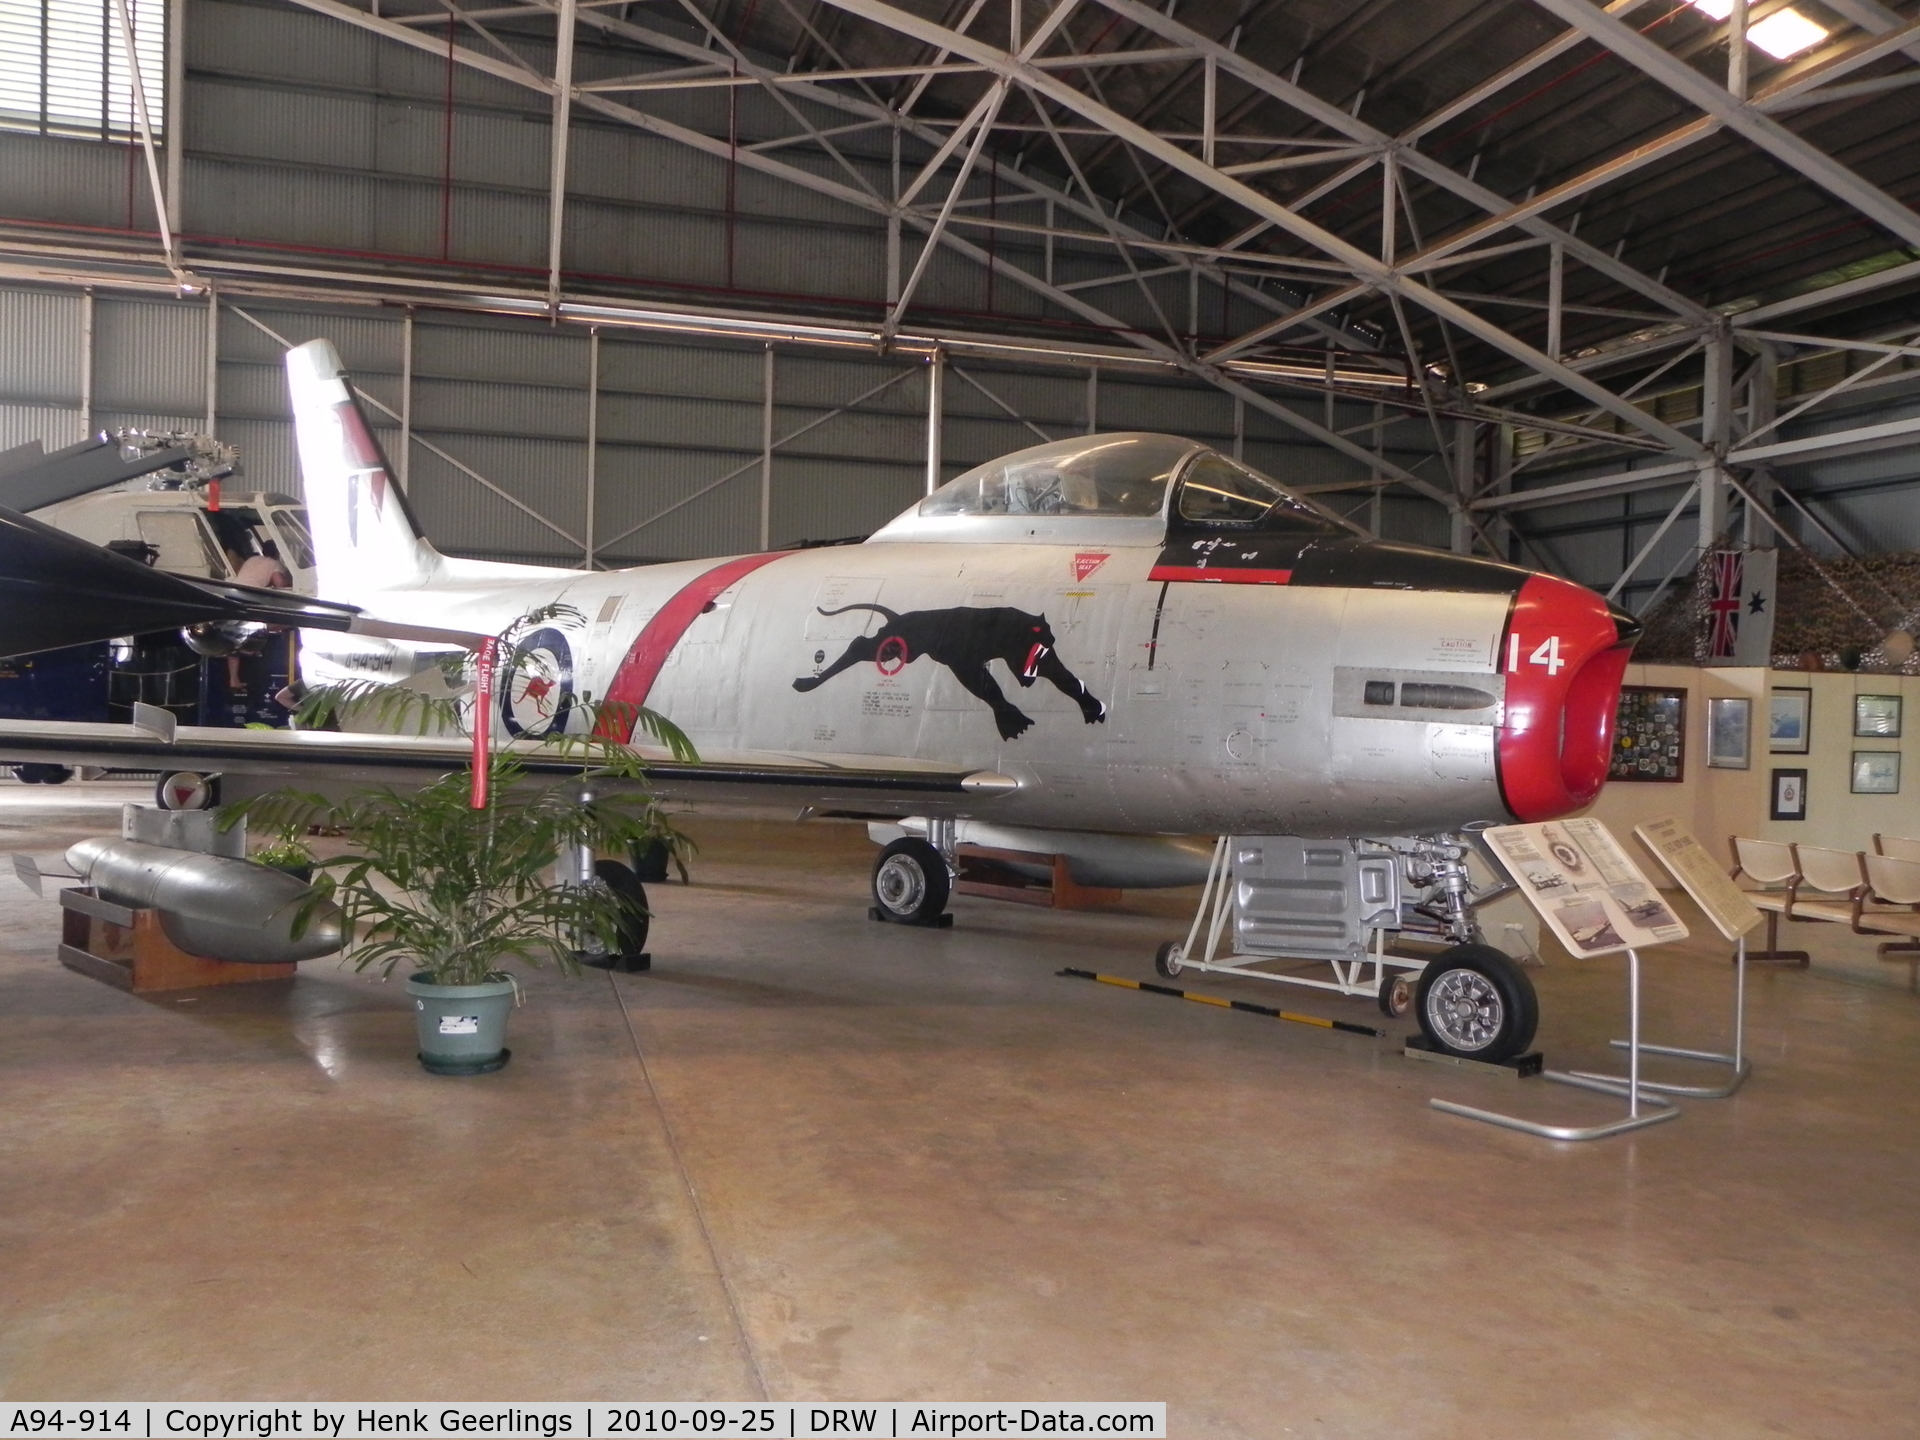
920,436,1192,516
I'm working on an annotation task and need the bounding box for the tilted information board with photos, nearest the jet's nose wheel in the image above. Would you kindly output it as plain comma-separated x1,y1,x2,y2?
1486,818,1688,956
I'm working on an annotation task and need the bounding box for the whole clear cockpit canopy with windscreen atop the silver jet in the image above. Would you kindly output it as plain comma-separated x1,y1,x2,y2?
877,432,1344,540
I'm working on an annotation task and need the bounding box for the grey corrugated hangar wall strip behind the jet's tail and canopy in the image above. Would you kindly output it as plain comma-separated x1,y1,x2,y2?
0,288,1413,564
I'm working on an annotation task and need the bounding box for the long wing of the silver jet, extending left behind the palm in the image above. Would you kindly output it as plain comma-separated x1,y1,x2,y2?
0,720,1020,814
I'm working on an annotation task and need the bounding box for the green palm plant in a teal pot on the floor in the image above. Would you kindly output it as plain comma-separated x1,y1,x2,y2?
227,612,697,1075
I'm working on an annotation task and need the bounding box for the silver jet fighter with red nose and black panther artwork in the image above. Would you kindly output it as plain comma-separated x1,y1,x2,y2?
0,340,1634,1075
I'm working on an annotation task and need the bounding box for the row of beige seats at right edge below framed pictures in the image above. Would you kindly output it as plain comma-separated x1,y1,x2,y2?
1728,835,1920,966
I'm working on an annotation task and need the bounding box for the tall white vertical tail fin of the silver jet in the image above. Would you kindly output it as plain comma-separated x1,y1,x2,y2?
286,340,440,601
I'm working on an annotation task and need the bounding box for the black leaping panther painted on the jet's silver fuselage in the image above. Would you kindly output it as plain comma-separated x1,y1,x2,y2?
793,605,1106,739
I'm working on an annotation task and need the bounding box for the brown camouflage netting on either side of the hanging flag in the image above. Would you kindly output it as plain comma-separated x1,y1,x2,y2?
1634,549,1920,674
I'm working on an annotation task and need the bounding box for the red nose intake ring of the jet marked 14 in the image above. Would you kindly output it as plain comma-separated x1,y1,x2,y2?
1500,574,1632,820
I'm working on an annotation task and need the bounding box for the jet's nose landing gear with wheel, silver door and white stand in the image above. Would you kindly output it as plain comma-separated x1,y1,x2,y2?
1154,835,1540,1064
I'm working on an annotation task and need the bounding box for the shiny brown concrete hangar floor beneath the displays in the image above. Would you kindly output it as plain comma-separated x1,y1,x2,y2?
0,783,1920,1440
